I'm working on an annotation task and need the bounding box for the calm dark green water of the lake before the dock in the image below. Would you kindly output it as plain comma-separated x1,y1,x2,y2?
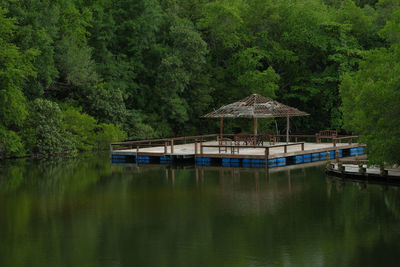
0,154,400,267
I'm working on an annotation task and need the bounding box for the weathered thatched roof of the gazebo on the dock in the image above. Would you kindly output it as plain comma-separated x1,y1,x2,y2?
202,94,309,118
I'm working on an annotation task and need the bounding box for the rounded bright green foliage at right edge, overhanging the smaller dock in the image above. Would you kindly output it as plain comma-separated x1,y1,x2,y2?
340,45,400,164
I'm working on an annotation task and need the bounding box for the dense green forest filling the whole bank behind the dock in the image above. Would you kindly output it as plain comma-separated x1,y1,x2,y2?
0,0,400,162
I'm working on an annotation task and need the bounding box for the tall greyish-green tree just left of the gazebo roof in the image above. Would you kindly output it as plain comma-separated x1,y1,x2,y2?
157,18,211,135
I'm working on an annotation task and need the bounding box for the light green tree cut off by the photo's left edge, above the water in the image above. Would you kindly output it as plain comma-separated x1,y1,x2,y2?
0,6,38,157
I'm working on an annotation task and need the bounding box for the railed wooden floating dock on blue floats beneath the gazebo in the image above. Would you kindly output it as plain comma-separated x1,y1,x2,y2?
110,135,365,168
